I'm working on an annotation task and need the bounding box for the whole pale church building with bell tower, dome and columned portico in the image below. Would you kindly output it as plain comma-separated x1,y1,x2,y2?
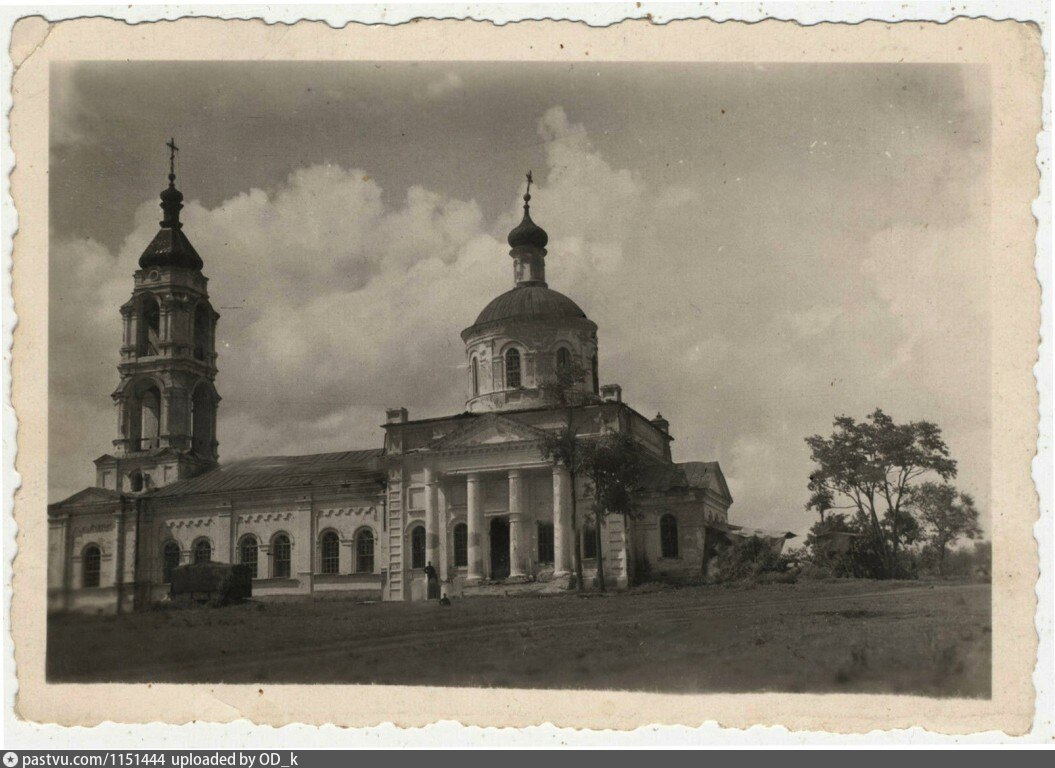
47,160,736,610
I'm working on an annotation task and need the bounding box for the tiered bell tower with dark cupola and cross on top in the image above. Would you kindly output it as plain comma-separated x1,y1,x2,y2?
95,140,219,493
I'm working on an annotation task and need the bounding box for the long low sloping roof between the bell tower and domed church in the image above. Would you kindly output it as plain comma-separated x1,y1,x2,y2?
151,448,384,498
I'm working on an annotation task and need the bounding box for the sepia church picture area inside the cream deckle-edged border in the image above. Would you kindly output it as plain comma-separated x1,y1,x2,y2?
10,16,1039,738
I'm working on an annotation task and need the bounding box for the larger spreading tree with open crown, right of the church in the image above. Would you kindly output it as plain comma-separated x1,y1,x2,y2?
806,408,956,578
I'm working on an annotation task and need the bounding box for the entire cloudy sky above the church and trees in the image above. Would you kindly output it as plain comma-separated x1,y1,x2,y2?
49,62,991,535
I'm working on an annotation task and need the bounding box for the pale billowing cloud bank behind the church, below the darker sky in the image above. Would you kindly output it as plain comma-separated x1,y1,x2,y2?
50,104,989,544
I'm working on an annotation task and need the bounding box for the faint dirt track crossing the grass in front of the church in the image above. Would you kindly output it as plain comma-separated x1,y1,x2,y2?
111,584,989,681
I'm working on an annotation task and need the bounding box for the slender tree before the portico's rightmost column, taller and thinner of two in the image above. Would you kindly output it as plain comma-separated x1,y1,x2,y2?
539,363,587,591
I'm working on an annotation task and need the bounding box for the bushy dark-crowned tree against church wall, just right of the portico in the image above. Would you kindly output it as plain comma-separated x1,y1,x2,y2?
579,431,645,592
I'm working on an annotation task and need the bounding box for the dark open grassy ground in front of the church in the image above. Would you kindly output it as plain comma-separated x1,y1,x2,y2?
47,581,991,697
